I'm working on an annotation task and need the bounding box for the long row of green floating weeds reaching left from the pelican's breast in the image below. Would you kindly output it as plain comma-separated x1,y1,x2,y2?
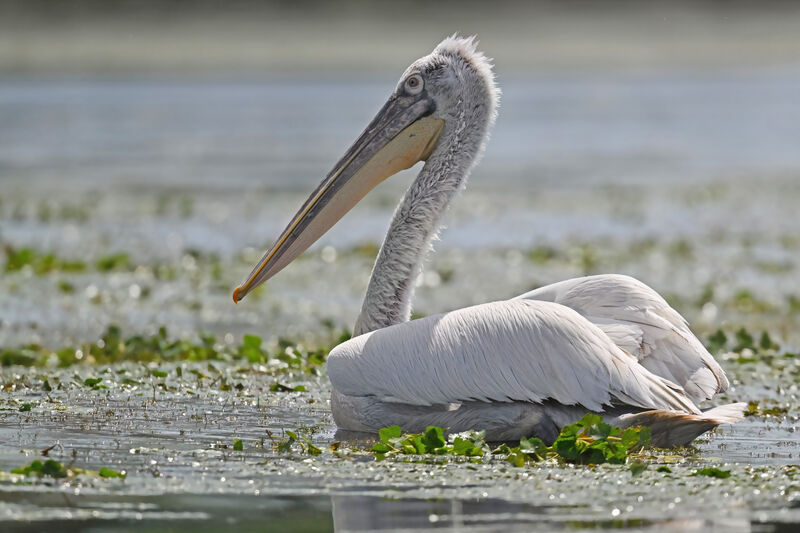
0,325,349,374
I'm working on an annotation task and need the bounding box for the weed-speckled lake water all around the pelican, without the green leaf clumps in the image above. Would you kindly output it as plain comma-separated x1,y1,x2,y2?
0,67,800,531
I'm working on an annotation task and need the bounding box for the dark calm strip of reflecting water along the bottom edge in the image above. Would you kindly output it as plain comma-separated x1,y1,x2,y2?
0,492,796,533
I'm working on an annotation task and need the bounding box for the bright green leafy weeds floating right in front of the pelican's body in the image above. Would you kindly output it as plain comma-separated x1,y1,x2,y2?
372,413,650,467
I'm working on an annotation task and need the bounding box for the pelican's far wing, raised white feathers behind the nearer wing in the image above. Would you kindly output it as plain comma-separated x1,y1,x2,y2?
518,274,728,402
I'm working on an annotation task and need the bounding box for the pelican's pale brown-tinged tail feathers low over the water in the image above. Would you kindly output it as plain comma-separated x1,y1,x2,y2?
619,403,747,448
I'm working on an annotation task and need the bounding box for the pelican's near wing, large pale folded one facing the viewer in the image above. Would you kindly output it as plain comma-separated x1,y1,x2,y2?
328,300,699,413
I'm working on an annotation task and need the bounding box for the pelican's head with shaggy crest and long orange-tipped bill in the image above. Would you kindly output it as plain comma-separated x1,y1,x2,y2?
233,36,499,302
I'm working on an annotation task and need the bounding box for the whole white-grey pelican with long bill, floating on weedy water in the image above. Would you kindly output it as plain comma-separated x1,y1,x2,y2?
233,35,744,447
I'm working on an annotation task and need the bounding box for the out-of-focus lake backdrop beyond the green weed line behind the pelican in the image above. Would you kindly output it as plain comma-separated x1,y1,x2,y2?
0,0,800,346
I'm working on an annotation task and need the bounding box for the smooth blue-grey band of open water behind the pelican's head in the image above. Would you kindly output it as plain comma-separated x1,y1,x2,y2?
0,67,800,191
